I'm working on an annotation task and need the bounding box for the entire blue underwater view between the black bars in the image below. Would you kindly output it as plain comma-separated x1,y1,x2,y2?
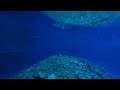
0,11,120,79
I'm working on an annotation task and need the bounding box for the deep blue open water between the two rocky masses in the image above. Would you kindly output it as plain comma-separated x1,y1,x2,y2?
0,11,120,78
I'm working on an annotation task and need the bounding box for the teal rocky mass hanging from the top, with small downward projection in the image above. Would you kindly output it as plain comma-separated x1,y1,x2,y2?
43,11,120,29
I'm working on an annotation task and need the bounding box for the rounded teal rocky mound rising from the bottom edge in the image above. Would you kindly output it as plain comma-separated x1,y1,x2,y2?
12,55,112,79
